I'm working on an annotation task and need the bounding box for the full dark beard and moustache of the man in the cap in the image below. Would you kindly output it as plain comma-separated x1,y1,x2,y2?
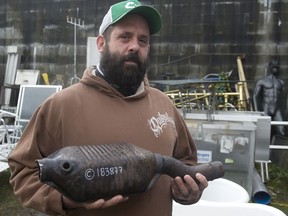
100,46,148,96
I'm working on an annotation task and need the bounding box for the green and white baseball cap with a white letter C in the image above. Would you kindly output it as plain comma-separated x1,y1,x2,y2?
99,0,162,35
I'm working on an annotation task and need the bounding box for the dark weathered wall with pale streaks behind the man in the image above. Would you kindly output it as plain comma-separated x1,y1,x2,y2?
0,0,288,89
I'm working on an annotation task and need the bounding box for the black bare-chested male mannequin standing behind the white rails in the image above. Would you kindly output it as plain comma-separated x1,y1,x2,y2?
253,60,285,136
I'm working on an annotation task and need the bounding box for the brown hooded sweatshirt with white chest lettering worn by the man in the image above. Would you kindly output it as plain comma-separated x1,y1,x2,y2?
8,67,196,216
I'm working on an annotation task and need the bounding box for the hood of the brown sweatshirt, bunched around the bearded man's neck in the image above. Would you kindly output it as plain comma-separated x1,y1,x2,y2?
80,66,150,100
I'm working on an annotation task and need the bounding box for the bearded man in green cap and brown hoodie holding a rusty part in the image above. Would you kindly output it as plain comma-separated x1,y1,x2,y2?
9,1,207,216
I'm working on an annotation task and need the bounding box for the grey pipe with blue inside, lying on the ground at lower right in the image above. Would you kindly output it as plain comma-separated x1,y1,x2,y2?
252,168,271,205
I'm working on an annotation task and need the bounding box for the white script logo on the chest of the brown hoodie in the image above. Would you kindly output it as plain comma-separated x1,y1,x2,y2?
148,112,175,137
